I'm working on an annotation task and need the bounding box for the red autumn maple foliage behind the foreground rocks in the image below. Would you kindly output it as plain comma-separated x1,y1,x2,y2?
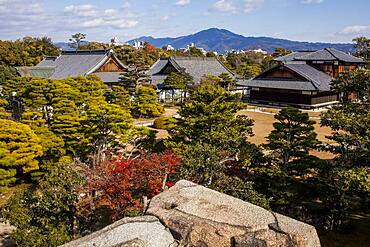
79,151,181,221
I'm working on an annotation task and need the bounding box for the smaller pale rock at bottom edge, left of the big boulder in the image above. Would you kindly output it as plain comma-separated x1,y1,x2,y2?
63,216,177,247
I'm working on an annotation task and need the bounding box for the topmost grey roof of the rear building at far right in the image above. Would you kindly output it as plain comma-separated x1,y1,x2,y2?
275,48,364,63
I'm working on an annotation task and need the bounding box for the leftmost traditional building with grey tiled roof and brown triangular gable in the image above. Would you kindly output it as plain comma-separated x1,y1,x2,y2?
17,50,127,86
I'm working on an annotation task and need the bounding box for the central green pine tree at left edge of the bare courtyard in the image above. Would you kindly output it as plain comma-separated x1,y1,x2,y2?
171,84,253,149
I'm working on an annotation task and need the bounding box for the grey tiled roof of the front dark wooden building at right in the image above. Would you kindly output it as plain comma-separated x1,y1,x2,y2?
243,64,332,91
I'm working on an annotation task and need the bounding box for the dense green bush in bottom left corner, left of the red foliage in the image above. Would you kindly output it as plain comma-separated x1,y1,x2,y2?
0,162,84,246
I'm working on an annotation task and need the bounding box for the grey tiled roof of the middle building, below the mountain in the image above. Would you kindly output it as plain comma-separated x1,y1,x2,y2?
150,57,234,84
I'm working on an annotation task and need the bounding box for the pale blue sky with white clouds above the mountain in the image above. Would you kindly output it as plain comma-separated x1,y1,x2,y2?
0,0,370,42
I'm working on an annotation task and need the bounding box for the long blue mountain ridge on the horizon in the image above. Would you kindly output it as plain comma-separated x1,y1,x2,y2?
128,28,354,53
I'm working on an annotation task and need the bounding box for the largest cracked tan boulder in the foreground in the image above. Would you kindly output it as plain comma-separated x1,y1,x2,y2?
147,181,320,247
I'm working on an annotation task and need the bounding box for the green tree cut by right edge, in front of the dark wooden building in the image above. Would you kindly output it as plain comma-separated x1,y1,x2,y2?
321,70,370,166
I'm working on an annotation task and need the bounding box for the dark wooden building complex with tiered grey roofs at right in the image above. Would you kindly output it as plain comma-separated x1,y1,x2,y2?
238,48,364,108
